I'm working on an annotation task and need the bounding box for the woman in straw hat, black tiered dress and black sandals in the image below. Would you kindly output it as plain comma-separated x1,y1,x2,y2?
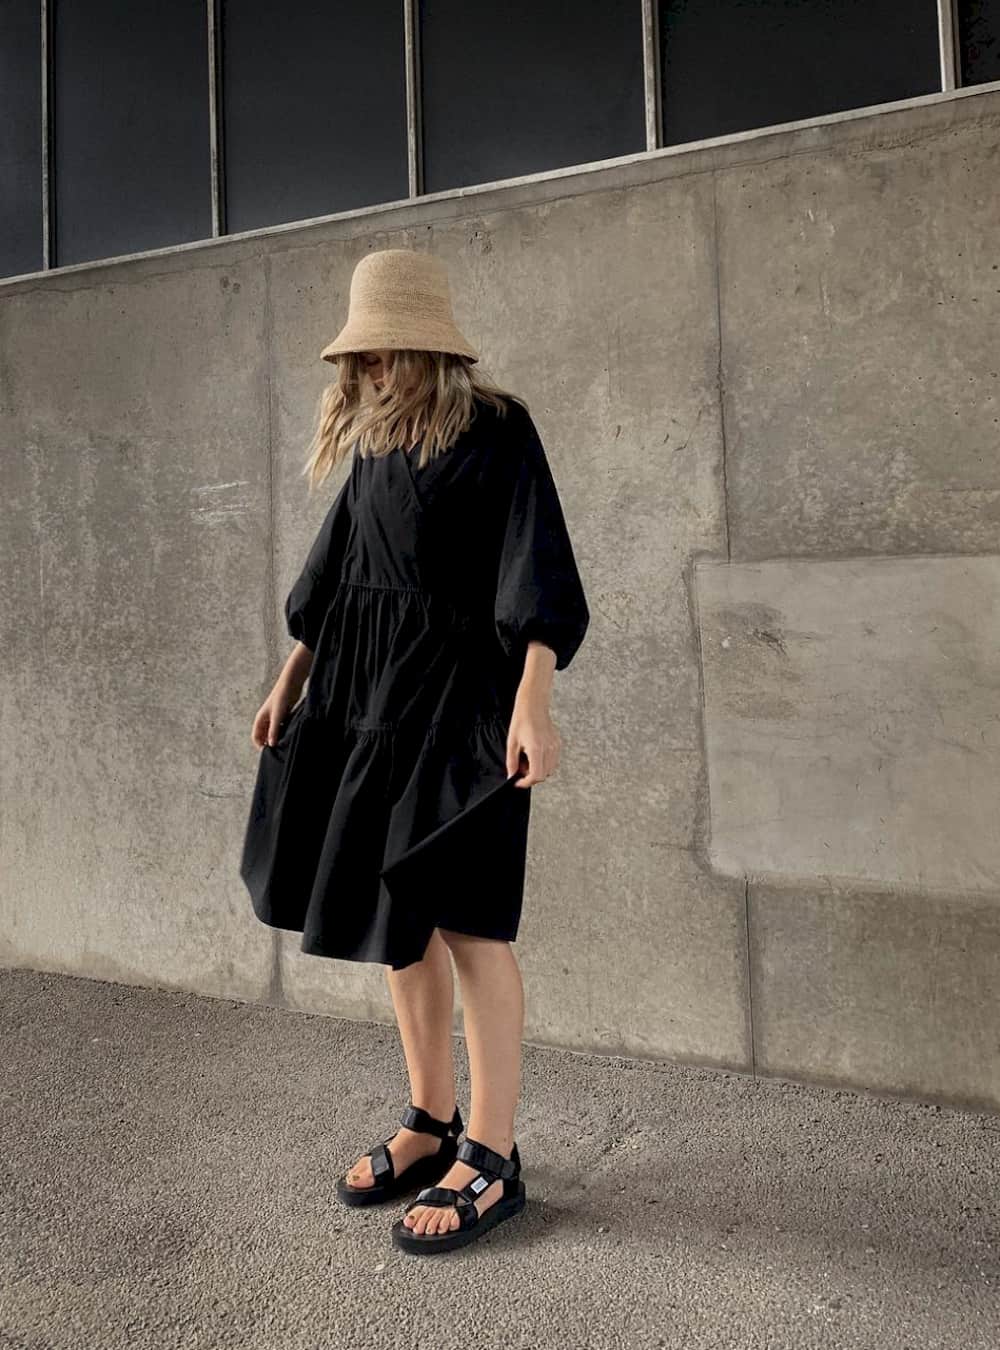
240,248,590,1253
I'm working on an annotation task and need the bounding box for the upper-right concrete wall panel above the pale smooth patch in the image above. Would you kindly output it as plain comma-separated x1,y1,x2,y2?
717,113,1000,559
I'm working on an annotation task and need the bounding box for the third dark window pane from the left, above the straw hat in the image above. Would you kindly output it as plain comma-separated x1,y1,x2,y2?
223,0,409,232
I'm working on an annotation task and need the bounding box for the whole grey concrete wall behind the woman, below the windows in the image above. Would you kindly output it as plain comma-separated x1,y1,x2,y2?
0,86,1000,1108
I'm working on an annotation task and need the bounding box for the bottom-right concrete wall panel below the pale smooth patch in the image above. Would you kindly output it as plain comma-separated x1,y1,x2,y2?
750,884,1000,1111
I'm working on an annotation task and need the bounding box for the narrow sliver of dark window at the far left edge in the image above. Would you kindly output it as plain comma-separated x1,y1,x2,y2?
0,0,43,277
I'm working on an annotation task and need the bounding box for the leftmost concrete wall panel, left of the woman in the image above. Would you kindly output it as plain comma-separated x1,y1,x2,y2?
0,266,271,998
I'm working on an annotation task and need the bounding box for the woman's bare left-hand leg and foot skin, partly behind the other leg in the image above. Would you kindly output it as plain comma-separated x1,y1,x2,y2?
347,929,455,1187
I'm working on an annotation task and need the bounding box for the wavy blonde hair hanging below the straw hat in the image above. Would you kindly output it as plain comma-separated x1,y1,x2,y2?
302,347,528,493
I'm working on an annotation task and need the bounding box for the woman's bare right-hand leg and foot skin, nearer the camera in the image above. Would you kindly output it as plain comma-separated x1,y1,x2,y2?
404,930,524,1233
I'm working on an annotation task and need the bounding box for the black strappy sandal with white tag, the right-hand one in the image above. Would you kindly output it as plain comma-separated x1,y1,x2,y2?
391,1138,525,1254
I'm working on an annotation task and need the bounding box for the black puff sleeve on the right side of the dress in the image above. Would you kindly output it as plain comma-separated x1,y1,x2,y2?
494,413,590,671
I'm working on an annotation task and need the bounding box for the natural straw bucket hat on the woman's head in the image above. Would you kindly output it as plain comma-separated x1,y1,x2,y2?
320,248,479,362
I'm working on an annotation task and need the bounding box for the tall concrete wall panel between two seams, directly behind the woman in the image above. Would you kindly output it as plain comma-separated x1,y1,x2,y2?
269,177,748,1042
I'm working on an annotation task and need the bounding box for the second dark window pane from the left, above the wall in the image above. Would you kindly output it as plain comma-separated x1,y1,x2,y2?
53,0,212,266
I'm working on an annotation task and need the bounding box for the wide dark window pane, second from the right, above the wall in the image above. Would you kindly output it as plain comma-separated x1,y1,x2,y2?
659,0,941,146
